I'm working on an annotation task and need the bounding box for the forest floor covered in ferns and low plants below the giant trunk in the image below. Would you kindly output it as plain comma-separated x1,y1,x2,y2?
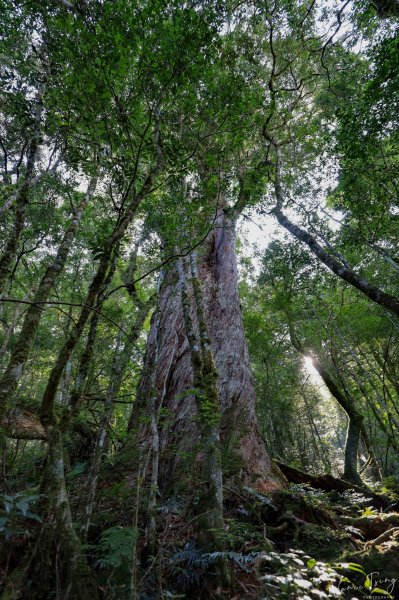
0,472,399,600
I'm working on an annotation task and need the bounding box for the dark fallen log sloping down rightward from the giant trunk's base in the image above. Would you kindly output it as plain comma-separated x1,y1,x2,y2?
274,460,389,509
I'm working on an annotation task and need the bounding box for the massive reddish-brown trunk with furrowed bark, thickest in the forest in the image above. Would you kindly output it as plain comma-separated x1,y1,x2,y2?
124,209,285,491
